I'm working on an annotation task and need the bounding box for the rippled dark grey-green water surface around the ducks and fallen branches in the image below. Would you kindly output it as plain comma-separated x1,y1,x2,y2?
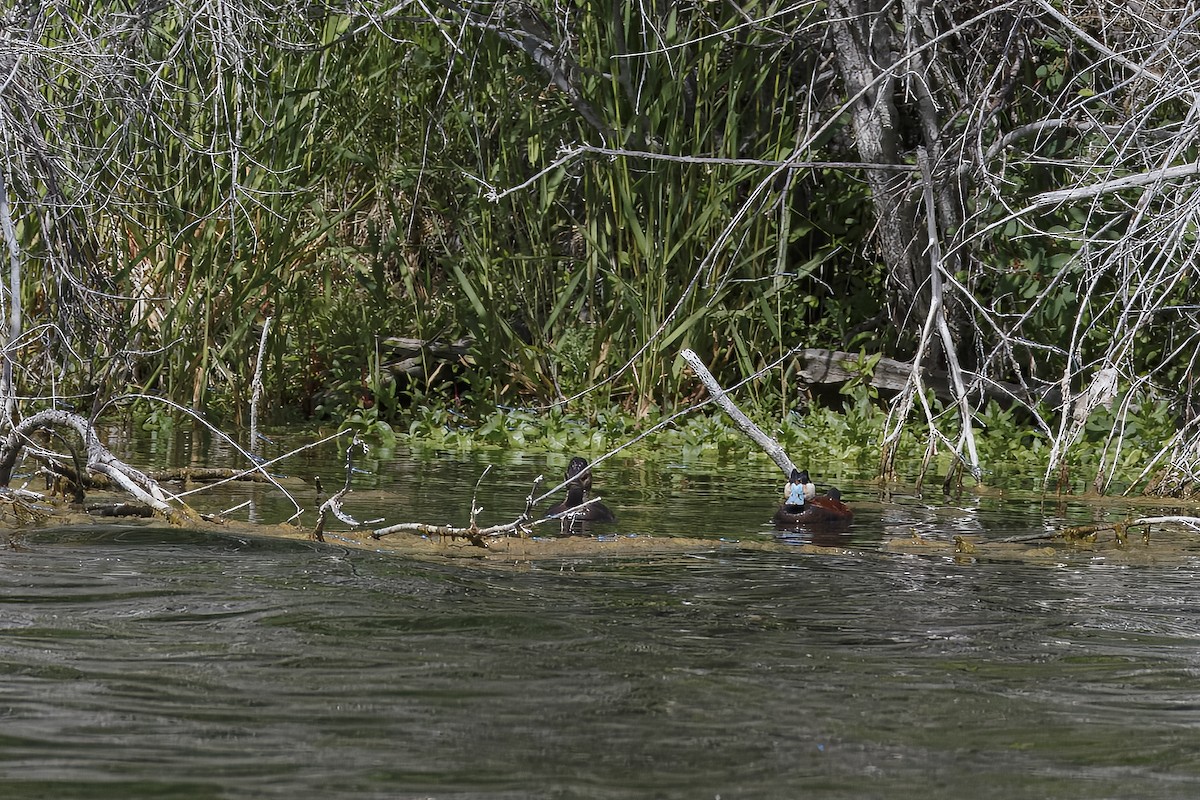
0,441,1200,799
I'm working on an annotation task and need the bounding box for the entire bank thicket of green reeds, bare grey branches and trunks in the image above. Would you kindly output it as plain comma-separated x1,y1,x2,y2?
0,0,1200,491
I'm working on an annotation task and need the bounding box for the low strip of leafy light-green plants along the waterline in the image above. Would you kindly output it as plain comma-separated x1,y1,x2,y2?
388,379,1174,491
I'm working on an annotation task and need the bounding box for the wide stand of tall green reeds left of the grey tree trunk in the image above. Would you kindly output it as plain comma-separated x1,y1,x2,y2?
0,0,883,415
